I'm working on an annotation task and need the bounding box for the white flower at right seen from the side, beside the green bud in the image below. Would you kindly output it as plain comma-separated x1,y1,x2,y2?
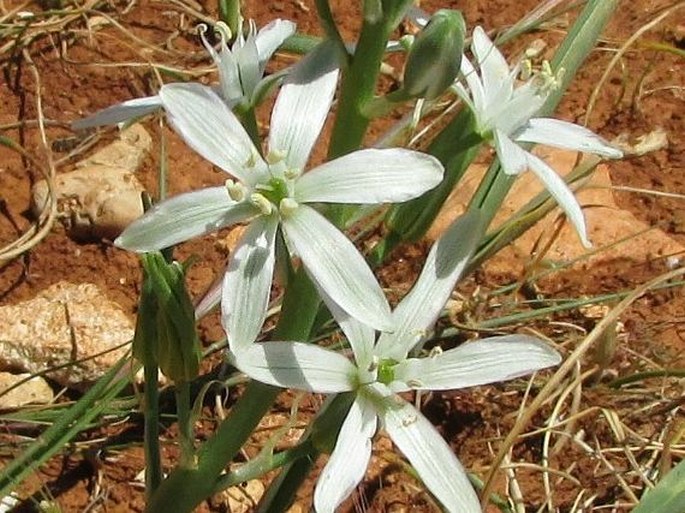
455,27,623,247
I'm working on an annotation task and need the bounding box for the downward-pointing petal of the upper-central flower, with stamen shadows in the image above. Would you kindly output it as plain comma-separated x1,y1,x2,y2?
221,216,278,352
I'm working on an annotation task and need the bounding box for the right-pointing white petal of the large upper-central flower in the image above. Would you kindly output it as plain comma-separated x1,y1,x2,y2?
295,148,443,204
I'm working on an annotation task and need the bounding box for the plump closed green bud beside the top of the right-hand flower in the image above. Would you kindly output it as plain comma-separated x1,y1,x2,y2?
403,9,466,100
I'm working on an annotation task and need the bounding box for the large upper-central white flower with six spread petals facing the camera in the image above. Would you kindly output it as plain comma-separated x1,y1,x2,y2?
115,46,443,350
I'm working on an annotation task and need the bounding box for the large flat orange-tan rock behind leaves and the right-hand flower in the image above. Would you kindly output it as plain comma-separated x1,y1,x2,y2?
428,148,685,276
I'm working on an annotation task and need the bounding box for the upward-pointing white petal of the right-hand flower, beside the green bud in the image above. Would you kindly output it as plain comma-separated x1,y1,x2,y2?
471,26,515,106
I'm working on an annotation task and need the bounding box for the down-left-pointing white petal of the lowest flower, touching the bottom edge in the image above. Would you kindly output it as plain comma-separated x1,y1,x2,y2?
314,396,378,513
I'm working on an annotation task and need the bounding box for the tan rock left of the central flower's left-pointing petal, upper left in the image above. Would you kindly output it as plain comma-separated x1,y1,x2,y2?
31,125,151,240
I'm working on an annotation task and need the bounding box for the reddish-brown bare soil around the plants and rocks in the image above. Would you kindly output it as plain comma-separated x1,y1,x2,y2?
0,0,685,512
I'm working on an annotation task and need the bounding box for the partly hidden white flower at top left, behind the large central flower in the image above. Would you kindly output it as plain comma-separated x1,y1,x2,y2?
72,19,295,130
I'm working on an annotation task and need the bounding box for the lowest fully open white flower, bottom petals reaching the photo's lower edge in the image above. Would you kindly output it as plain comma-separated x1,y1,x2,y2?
232,210,560,513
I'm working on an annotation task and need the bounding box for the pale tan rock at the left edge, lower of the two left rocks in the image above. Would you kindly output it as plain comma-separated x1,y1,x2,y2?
0,281,134,388
